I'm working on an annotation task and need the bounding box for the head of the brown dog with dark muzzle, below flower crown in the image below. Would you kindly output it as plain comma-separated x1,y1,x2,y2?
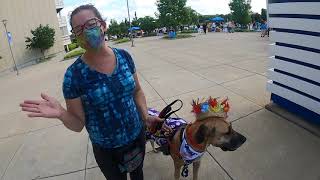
195,117,246,151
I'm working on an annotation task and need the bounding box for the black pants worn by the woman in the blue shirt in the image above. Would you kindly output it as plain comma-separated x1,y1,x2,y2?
92,131,145,180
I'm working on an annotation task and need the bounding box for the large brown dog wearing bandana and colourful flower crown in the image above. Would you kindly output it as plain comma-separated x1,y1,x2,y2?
165,117,246,180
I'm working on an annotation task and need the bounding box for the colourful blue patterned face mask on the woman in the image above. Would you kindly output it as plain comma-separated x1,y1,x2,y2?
83,26,104,50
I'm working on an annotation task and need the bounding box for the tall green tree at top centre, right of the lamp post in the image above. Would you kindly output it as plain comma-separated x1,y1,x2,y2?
156,0,187,29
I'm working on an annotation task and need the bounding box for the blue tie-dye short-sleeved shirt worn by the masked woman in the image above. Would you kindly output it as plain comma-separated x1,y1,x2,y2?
63,48,143,148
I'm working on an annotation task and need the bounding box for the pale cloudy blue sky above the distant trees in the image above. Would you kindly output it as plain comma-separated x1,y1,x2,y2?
61,0,266,28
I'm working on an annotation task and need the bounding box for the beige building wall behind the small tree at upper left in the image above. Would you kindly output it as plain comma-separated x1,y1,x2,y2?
0,0,64,72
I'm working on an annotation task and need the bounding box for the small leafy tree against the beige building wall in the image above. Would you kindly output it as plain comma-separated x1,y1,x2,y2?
25,24,55,61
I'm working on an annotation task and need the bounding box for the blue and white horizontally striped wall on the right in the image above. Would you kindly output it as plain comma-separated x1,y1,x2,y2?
267,0,320,124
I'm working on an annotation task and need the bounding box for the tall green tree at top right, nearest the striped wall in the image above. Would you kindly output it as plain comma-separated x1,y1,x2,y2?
229,0,251,25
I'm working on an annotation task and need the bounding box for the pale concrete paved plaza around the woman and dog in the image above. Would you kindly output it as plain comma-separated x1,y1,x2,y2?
0,33,320,180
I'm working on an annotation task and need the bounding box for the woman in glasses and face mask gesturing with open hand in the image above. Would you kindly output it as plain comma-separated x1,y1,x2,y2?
21,5,169,180
